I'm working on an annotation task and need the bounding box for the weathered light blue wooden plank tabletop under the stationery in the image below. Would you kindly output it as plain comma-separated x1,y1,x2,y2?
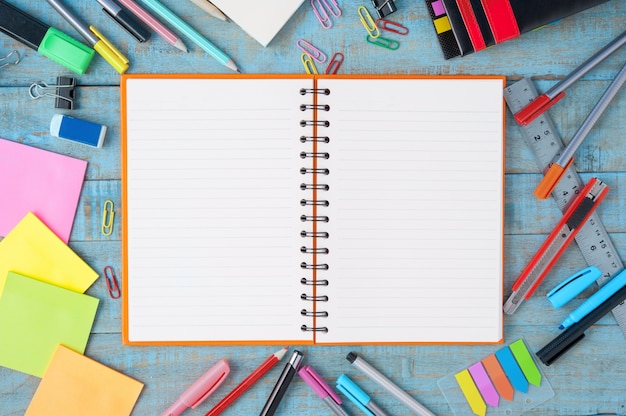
0,0,626,416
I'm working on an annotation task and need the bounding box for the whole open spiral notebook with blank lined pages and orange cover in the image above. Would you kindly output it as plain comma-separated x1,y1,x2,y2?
122,75,504,345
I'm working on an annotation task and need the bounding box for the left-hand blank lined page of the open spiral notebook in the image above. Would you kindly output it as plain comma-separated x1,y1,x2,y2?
124,77,311,342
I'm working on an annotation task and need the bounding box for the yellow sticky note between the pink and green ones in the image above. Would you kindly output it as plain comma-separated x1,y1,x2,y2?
0,213,98,293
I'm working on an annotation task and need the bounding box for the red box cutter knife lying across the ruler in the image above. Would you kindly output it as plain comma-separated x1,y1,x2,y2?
503,178,609,315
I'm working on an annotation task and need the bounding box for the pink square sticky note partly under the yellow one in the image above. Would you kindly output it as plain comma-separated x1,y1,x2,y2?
0,139,87,243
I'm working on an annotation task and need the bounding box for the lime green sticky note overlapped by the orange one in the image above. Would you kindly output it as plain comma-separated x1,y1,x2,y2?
0,272,99,377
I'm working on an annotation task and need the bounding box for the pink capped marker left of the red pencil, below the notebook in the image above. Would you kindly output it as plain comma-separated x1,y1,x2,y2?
161,359,230,416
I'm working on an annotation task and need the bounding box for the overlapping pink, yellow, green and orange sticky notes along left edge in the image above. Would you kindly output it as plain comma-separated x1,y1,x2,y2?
0,139,143,416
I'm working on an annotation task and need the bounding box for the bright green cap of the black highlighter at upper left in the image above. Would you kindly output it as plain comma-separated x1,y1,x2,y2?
37,27,95,74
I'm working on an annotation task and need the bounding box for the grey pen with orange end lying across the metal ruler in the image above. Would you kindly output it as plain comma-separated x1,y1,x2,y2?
535,61,626,199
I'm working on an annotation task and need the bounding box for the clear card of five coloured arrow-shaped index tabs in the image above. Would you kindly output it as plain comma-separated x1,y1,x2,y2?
437,338,554,416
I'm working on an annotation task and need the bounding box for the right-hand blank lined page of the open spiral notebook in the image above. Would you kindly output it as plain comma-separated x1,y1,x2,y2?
317,78,504,343
